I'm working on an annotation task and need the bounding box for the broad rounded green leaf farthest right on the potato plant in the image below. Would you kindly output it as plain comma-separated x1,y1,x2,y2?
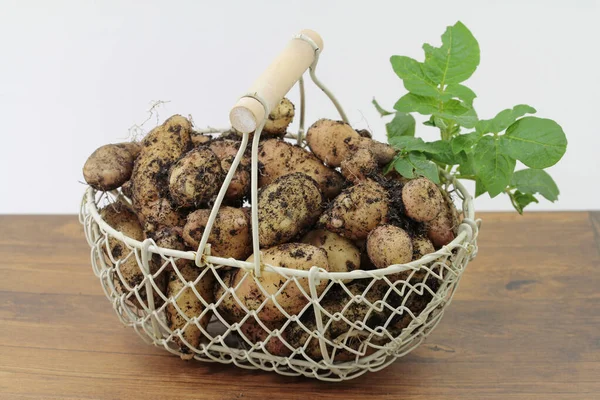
500,117,567,169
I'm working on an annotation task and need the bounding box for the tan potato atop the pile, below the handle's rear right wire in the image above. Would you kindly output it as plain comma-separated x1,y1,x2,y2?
306,119,363,167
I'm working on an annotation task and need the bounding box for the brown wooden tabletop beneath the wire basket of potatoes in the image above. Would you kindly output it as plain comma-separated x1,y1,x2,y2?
0,212,600,400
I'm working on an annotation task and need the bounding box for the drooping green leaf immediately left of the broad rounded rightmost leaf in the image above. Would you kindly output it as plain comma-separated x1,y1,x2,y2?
473,136,516,197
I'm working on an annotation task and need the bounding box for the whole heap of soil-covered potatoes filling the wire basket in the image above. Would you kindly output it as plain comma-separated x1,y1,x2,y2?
83,99,458,360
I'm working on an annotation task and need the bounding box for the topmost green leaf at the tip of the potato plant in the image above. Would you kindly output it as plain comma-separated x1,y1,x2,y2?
423,22,479,86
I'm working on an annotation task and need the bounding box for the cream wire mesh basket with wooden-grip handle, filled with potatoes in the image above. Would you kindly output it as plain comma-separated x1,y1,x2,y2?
80,31,479,381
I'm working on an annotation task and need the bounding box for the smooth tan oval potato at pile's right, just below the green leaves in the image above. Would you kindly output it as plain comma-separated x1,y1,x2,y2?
402,178,443,222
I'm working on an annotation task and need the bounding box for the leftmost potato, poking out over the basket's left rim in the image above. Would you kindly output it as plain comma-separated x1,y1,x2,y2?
83,143,139,191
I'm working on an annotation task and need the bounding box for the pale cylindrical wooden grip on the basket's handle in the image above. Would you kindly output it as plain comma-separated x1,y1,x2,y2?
229,29,323,133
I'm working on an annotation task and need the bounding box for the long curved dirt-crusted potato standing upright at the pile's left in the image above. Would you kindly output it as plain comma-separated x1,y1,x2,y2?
131,115,192,232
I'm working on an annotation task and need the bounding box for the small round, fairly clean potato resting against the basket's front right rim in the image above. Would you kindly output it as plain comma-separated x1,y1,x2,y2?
367,225,413,268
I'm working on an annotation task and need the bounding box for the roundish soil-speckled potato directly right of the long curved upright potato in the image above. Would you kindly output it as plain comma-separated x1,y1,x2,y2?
169,147,225,207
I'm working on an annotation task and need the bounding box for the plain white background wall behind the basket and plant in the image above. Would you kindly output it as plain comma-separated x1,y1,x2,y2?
0,0,600,213
